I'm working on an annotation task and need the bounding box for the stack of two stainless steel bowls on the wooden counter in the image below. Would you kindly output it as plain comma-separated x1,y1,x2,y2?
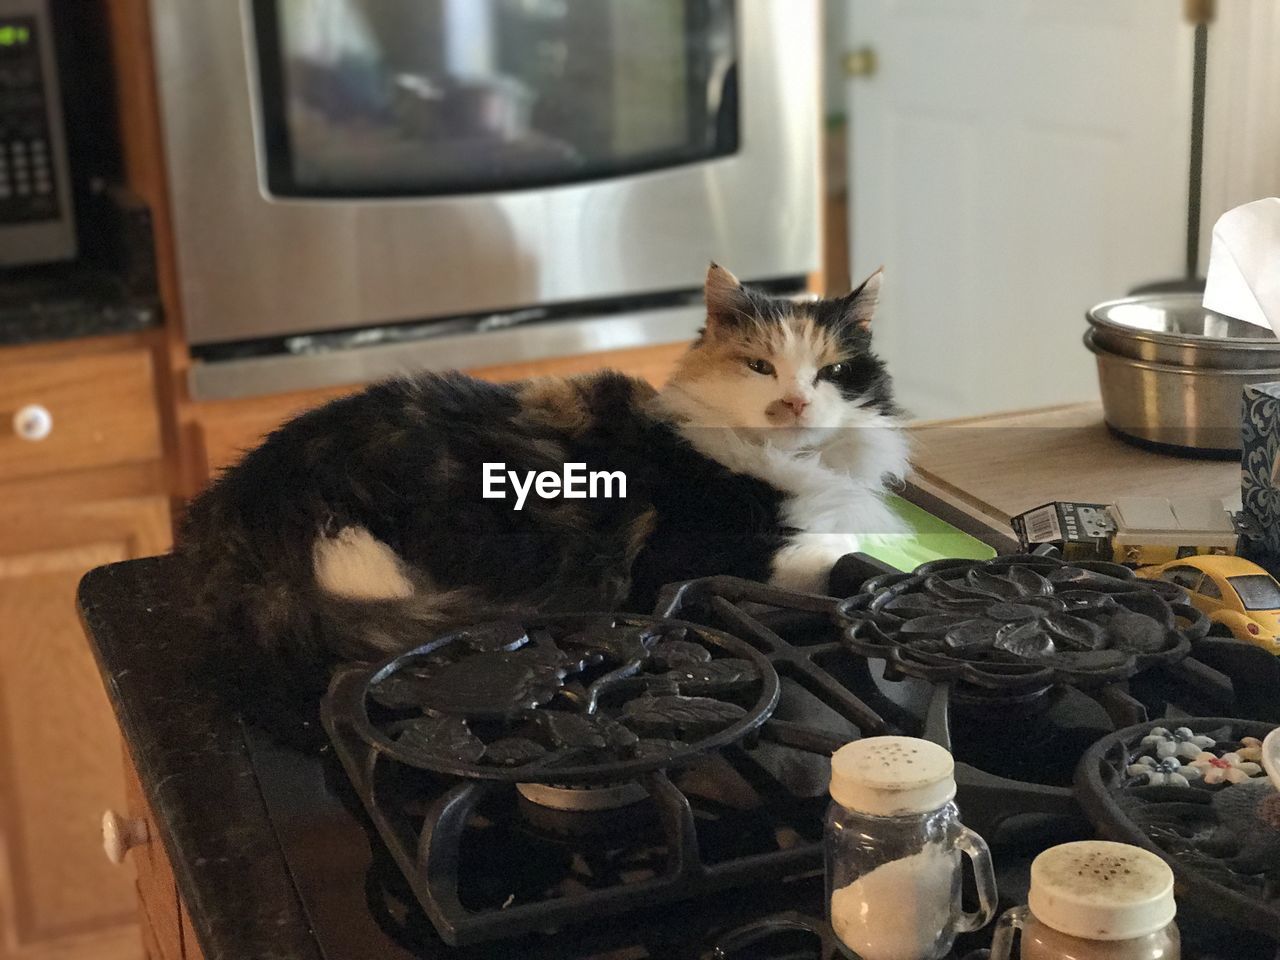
1084,293,1280,457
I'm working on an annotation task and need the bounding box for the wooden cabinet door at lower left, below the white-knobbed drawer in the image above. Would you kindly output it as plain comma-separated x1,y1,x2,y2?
0,497,170,960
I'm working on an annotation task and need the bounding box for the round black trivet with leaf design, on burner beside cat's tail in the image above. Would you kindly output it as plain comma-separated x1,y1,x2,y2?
325,614,780,788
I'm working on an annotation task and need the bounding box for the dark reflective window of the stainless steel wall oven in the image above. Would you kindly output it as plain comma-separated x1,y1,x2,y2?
253,0,739,197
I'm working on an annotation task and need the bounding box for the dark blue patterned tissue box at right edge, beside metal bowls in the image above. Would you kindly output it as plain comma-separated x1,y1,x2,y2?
1240,383,1280,573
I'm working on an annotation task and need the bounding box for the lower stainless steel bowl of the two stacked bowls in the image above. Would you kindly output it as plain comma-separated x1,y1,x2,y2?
1084,329,1280,457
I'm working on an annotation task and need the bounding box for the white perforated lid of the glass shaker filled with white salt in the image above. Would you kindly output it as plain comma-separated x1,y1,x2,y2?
831,737,956,817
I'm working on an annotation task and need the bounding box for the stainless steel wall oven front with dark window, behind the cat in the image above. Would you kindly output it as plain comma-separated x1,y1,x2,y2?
151,0,820,396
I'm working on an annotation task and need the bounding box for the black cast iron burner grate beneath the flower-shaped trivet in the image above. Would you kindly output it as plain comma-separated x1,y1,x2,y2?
658,554,1280,840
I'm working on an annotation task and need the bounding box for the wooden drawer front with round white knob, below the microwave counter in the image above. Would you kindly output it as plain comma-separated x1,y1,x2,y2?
0,349,163,481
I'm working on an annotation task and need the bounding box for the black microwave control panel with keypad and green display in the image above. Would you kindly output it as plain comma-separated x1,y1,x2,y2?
0,17,59,224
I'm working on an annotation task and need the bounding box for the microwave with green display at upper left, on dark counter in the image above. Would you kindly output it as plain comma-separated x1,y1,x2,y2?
0,0,76,266
